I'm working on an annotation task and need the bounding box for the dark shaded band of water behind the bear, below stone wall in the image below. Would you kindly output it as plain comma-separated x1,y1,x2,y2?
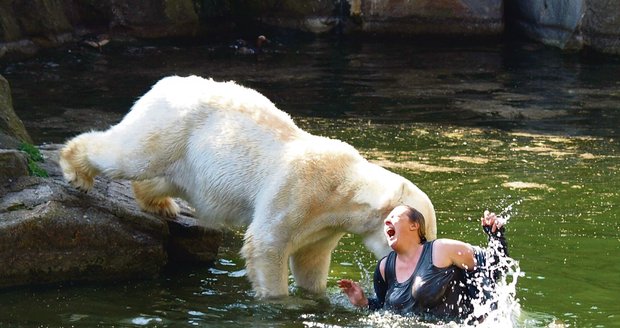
0,32,620,143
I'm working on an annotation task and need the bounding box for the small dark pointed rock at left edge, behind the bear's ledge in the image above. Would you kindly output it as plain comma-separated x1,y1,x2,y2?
0,75,32,148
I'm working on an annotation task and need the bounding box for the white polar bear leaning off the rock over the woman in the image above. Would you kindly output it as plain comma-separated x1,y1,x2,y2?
60,76,436,298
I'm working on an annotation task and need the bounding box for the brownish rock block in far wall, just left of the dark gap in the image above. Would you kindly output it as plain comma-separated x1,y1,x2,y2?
348,0,504,36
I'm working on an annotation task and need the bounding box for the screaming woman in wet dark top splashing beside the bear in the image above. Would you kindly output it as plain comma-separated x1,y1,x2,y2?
338,205,508,320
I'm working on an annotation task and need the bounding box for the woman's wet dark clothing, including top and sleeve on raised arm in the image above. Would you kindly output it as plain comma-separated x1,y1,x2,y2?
368,229,508,321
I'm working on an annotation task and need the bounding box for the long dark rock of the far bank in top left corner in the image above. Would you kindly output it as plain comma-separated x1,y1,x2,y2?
0,0,200,57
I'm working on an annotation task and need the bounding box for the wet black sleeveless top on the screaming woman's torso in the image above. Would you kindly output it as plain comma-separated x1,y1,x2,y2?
377,241,473,320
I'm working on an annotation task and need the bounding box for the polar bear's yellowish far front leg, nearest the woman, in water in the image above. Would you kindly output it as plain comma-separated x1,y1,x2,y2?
291,234,342,295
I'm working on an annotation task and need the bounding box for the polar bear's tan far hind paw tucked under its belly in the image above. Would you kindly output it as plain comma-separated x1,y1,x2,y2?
131,178,181,217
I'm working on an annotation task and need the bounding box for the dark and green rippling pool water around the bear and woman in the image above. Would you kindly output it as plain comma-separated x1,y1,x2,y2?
0,36,620,327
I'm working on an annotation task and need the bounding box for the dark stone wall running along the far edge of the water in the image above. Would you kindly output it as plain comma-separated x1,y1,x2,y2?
0,0,620,57
